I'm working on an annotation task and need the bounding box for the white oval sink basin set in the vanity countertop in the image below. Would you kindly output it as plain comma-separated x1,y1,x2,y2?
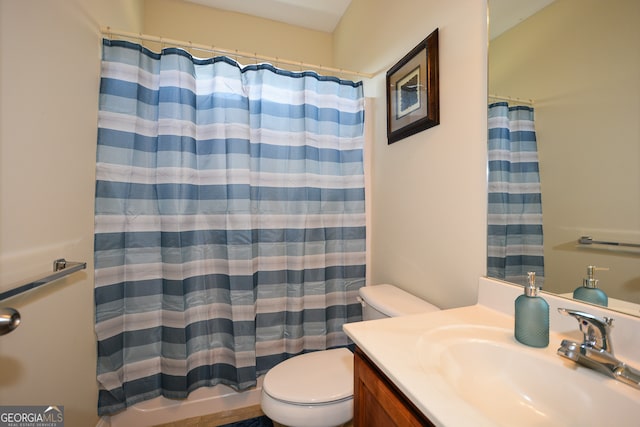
417,325,640,427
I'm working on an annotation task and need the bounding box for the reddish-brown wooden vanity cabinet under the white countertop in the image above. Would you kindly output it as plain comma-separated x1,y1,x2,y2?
353,347,434,427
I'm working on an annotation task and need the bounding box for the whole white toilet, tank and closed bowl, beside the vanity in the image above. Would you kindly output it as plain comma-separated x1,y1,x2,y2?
261,285,439,427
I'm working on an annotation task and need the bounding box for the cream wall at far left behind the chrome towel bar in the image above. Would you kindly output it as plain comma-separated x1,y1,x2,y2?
0,0,142,427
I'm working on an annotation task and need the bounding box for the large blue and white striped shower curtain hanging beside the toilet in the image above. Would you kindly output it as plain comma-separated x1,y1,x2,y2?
95,40,365,414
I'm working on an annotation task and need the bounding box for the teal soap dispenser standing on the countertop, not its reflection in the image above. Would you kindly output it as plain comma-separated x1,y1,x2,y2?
514,272,549,347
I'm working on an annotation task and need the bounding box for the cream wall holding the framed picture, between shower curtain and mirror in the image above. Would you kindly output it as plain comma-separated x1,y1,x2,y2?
334,0,487,308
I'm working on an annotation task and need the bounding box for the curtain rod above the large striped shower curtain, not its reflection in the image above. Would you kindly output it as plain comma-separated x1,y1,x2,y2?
100,27,373,79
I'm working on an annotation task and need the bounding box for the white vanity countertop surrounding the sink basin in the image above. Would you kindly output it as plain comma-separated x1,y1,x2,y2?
344,279,640,427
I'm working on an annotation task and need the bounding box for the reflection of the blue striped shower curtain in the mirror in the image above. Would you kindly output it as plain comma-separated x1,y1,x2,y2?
487,102,544,286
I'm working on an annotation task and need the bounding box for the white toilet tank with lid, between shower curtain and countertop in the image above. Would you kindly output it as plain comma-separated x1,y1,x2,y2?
359,284,440,320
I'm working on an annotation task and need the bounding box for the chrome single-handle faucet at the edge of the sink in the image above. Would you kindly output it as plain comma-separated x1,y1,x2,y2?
558,308,640,389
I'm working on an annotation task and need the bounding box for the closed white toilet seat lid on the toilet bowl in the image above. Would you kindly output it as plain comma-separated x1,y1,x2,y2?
262,348,353,406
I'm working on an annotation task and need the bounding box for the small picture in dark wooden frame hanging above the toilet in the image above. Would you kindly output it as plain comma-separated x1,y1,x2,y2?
387,28,440,144
